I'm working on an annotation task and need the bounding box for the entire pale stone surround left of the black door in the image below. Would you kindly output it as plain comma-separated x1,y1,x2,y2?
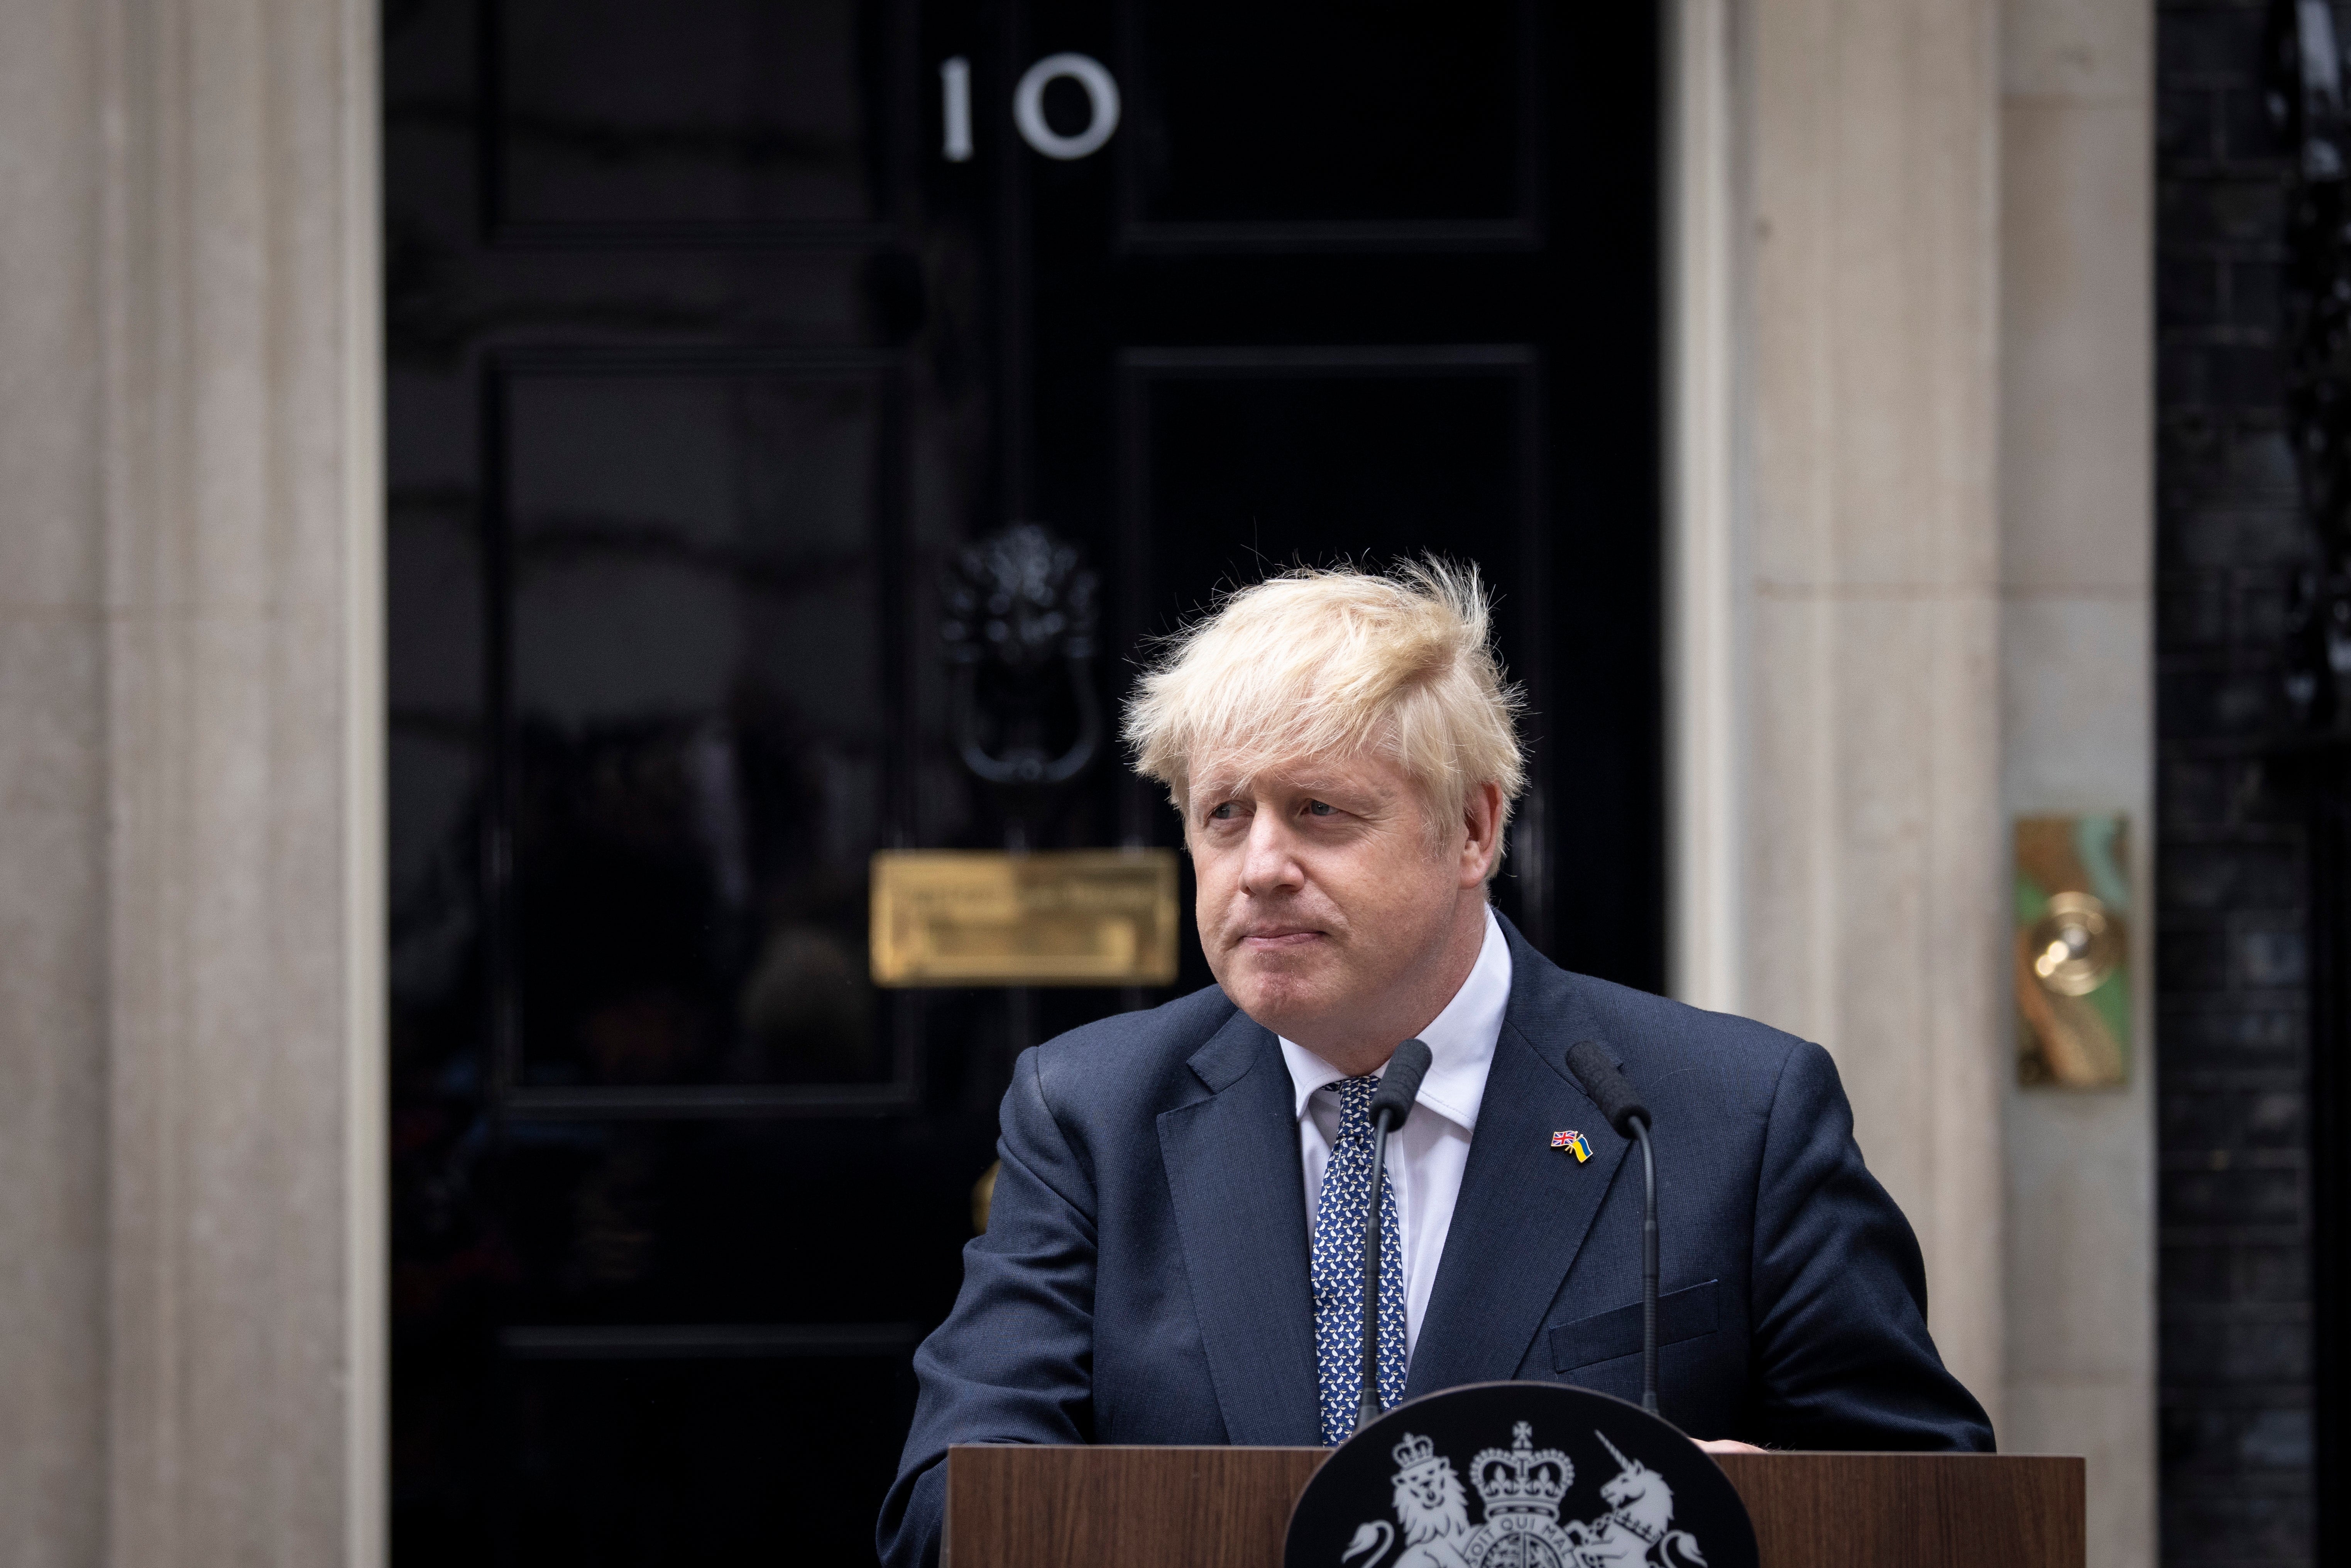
0,0,386,1568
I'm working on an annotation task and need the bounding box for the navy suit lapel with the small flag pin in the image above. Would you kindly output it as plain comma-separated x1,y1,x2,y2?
1404,922,1629,1399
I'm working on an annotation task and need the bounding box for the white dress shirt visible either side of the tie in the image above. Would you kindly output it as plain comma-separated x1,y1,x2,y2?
1281,910,1509,1357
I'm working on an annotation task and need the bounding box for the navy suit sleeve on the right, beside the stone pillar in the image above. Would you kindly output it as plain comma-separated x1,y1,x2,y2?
1752,1044,1991,1453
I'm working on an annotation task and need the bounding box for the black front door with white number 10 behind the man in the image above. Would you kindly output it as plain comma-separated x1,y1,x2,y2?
386,0,1662,1566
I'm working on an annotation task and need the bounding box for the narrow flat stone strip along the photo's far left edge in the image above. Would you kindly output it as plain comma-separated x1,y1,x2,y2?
0,0,108,1568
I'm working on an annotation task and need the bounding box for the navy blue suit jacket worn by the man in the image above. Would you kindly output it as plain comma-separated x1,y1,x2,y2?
879,922,1991,1568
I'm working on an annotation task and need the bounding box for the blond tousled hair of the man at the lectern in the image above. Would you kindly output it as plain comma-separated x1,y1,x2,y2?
1126,555,1526,846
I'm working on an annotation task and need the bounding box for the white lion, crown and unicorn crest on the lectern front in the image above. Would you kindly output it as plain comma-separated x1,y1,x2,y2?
1340,1420,1707,1568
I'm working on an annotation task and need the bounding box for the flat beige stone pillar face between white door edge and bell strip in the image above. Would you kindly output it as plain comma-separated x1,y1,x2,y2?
1744,0,2005,1422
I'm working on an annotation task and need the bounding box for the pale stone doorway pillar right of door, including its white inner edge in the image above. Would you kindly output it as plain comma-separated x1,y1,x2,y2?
1669,0,2005,1420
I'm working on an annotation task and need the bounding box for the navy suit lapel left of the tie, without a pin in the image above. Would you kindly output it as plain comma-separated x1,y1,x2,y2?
1159,1011,1321,1446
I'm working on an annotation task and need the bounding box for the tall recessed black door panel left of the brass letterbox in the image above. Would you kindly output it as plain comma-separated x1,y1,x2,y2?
489,350,908,1086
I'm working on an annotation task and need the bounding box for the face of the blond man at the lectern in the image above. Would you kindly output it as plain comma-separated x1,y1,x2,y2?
1185,754,1500,1060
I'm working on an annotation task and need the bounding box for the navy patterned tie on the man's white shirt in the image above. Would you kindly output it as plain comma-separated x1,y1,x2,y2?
1314,1074,1404,1446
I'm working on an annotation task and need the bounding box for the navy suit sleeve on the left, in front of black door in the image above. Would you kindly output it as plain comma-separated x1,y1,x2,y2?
877,1051,1096,1568
